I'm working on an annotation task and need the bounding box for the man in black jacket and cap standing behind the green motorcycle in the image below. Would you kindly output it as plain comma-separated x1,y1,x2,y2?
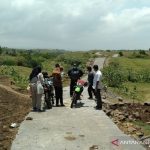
68,64,83,97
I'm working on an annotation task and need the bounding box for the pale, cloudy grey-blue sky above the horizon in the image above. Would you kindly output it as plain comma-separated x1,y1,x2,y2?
0,0,150,50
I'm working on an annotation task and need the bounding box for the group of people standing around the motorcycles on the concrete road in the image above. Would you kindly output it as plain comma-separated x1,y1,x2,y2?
29,64,102,112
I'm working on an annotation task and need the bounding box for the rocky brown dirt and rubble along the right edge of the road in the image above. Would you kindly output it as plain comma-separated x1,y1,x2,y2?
104,103,150,150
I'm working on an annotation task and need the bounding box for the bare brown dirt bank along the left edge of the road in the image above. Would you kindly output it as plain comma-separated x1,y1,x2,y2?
0,84,31,150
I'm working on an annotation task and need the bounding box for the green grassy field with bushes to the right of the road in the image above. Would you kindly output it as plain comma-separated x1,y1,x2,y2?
104,52,150,102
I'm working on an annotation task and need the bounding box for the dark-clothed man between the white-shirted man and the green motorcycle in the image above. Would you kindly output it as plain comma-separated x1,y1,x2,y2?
87,66,94,99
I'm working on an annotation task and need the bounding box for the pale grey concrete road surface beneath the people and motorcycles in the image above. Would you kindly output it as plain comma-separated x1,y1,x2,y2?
11,58,144,150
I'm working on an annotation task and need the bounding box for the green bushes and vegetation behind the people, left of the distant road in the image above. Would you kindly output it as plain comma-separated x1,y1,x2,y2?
0,47,93,86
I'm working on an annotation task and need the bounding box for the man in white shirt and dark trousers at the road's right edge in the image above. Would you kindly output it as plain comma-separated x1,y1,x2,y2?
93,65,102,110
